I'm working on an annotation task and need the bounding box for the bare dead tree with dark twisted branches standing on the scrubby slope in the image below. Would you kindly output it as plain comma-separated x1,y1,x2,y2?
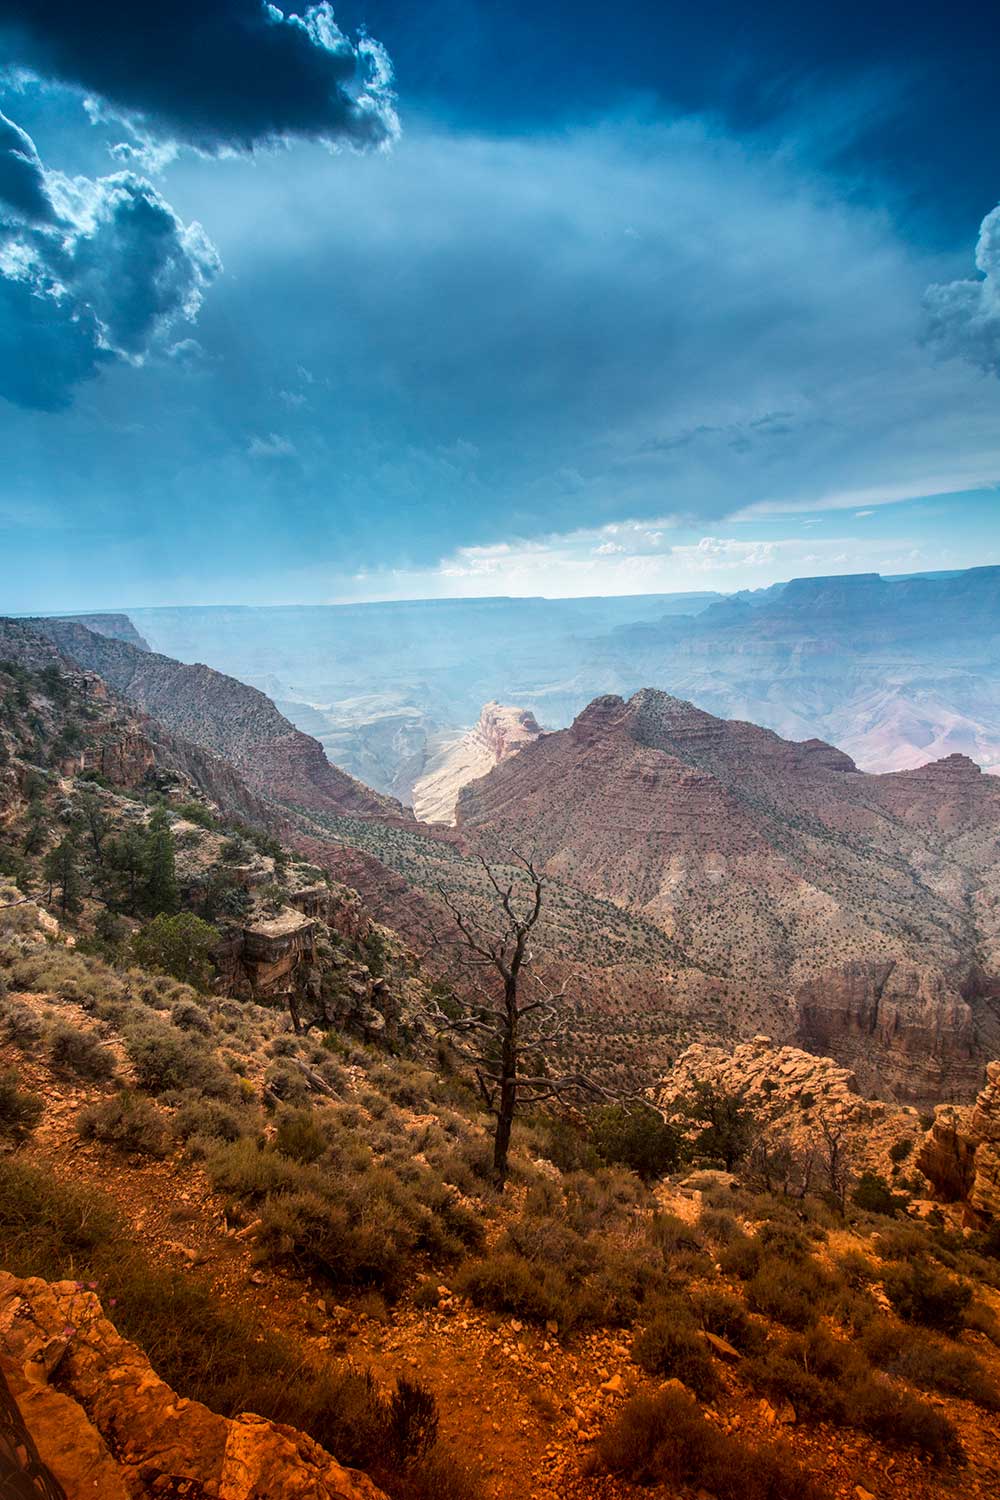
432,851,609,1193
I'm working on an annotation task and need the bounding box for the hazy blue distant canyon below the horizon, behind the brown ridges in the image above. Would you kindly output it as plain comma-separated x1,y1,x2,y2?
70,567,1000,804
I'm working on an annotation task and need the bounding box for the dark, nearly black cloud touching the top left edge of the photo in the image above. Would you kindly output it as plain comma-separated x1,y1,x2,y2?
0,0,399,153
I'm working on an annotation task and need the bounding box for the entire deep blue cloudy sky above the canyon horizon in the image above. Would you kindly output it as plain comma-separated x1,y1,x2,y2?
0,0,1000,612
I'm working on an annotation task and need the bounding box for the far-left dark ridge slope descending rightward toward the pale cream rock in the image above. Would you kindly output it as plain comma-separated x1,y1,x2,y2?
22,620,403,816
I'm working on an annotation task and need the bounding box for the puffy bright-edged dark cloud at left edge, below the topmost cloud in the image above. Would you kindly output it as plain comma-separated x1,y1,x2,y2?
0,116,220,410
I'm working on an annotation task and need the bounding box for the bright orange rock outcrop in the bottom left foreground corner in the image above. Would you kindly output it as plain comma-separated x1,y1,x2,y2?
0,1272,385,1500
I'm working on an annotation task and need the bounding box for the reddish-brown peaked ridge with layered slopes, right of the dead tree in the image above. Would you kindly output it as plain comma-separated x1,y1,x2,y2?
457,690,1000,1100
